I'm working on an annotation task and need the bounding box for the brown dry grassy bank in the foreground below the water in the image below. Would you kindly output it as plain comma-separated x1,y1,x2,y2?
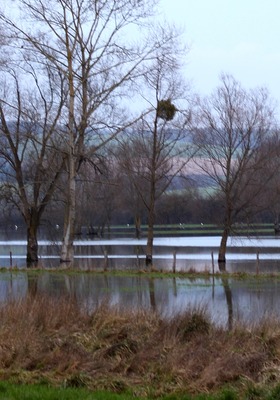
0,296,280,400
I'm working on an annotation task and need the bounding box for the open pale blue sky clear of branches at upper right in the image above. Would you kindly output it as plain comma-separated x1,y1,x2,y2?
160,0,280,108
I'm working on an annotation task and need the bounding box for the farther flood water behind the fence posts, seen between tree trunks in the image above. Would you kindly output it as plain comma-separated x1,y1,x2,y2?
0,236,280,273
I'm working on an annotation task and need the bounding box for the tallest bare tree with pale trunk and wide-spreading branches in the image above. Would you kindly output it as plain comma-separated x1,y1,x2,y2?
0,0,184,262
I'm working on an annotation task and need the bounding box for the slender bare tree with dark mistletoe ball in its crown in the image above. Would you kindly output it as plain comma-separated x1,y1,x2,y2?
115,55,191,267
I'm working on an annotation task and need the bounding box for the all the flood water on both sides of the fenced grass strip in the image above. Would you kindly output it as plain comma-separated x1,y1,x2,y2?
0,237,280,327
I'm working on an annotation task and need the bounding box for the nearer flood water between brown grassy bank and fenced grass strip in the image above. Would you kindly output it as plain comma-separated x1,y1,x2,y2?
0,271,280,329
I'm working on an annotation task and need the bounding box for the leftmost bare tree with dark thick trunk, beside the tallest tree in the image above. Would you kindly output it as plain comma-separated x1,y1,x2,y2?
0,67,64,265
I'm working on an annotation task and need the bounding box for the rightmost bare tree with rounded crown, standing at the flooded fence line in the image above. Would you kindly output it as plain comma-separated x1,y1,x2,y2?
193,75,274,268
